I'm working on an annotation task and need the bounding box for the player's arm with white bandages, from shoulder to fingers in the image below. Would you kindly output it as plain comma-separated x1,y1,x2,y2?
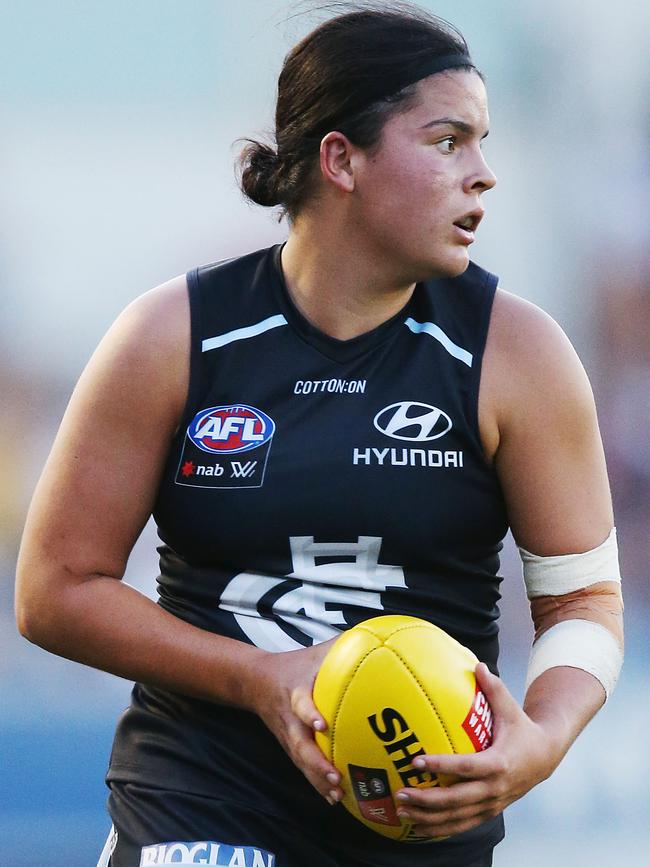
397,291,622,837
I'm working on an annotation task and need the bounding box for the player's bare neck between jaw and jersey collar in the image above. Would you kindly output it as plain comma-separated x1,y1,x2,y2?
282,217,415,340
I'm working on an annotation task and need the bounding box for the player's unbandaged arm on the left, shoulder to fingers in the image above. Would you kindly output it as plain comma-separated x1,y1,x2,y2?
16,277,336,796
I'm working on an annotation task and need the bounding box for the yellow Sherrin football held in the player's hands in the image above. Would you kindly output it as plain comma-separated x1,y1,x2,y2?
314,615,492,843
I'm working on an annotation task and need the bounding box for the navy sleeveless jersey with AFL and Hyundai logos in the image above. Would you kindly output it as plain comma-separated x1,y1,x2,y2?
109,245,507,865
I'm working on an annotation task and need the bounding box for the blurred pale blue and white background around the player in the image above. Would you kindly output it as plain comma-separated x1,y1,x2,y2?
0,0,650,867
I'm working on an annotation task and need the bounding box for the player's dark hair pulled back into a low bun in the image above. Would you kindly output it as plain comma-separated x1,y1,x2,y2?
239,3,480,219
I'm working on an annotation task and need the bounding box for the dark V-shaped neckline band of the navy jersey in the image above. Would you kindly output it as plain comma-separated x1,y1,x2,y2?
269,242,420,363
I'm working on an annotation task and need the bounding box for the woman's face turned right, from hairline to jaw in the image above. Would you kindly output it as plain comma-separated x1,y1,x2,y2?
354,70,496,280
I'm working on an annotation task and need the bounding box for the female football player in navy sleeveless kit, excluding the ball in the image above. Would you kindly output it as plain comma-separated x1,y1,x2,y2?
17,4,621,867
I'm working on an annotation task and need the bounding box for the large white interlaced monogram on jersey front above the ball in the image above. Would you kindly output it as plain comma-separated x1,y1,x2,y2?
219,536,406,651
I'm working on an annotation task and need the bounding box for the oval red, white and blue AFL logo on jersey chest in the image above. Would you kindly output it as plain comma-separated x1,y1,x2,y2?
187,404,275,454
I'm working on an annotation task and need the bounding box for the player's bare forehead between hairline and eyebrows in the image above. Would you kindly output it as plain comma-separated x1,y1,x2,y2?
403,70,489,135
